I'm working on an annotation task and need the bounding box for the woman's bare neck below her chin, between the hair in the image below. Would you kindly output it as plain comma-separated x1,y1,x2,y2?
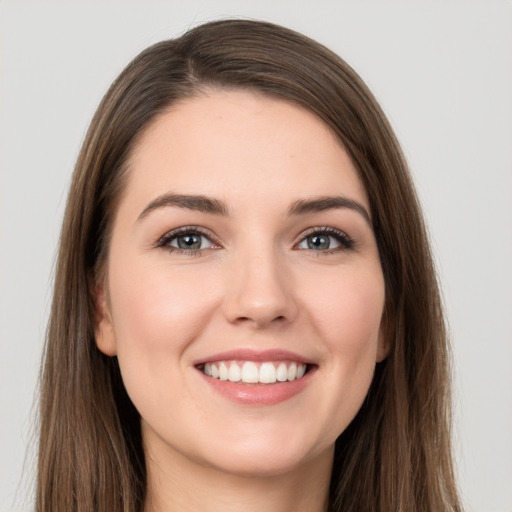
144,432,334,512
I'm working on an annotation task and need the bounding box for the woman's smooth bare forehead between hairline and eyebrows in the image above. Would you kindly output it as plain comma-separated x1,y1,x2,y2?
126,91,368,214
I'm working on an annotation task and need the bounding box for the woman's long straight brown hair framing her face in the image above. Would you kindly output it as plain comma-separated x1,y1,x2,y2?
37,20,461,512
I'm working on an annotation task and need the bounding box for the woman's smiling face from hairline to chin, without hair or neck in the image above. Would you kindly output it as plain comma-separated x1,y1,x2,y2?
96,91,386,475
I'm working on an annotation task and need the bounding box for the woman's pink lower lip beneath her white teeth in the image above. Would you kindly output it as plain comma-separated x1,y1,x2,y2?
198,367,316,405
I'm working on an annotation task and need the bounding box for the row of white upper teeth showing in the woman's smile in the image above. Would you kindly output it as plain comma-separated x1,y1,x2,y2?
203,361,306,384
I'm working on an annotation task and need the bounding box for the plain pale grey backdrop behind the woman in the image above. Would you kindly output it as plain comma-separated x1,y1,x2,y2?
0,0,512,512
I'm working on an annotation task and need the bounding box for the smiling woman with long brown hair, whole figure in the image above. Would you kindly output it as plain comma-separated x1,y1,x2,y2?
37,20,460,512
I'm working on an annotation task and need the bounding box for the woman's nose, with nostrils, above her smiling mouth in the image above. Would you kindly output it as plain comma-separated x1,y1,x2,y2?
223,247,298,329
